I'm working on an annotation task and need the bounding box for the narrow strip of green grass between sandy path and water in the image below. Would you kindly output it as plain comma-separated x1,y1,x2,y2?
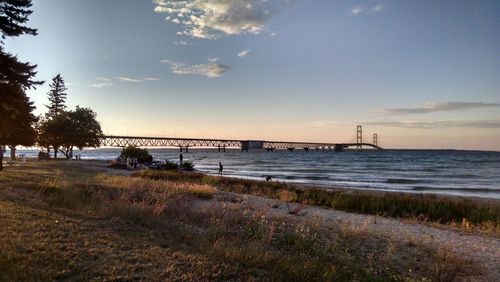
134,171,500,234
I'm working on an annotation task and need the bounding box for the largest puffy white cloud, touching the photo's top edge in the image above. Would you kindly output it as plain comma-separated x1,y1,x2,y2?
154,0,291,39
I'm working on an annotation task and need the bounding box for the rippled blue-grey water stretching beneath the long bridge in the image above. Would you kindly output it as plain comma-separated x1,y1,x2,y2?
6,148,500,199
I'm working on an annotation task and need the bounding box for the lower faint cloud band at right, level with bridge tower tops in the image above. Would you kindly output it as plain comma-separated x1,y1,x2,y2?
365,120,500,129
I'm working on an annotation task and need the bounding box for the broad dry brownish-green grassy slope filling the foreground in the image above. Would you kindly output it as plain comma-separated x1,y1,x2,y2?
0,162,474,281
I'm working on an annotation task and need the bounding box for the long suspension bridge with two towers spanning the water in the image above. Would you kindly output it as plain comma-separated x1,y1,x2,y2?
101,125,382,152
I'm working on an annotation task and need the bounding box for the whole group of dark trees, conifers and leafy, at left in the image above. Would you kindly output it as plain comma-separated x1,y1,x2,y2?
0,0,102,171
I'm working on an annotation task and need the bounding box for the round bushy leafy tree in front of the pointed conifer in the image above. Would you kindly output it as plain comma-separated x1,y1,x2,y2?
39,106,102,159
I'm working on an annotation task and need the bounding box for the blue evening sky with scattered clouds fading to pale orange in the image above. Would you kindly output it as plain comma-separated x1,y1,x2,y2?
5,0,500,151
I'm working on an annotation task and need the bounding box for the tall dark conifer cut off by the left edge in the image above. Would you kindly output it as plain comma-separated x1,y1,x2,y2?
0,0,43,171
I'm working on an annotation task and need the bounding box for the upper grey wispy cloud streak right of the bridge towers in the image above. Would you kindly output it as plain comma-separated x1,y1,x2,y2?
379,102,500,115
